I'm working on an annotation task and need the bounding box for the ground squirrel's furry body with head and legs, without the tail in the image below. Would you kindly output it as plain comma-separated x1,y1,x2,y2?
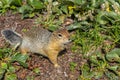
20,28,70,67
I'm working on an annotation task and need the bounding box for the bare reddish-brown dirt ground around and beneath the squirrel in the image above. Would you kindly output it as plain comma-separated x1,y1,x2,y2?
0,12,82,80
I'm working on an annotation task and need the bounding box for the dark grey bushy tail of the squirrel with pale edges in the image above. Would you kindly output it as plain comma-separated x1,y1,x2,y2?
1,29,22,48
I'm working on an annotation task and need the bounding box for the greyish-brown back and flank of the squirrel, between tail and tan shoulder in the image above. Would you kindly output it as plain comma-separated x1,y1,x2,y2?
20,28,51,55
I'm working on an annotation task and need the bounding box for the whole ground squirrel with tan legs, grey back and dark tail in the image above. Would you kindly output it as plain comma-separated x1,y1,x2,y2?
1,27,71,67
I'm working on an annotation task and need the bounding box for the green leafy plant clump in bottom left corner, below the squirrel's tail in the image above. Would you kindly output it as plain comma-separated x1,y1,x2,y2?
0,48,28,80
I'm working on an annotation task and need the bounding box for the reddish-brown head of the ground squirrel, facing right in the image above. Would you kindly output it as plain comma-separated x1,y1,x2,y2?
53,29,71,45
